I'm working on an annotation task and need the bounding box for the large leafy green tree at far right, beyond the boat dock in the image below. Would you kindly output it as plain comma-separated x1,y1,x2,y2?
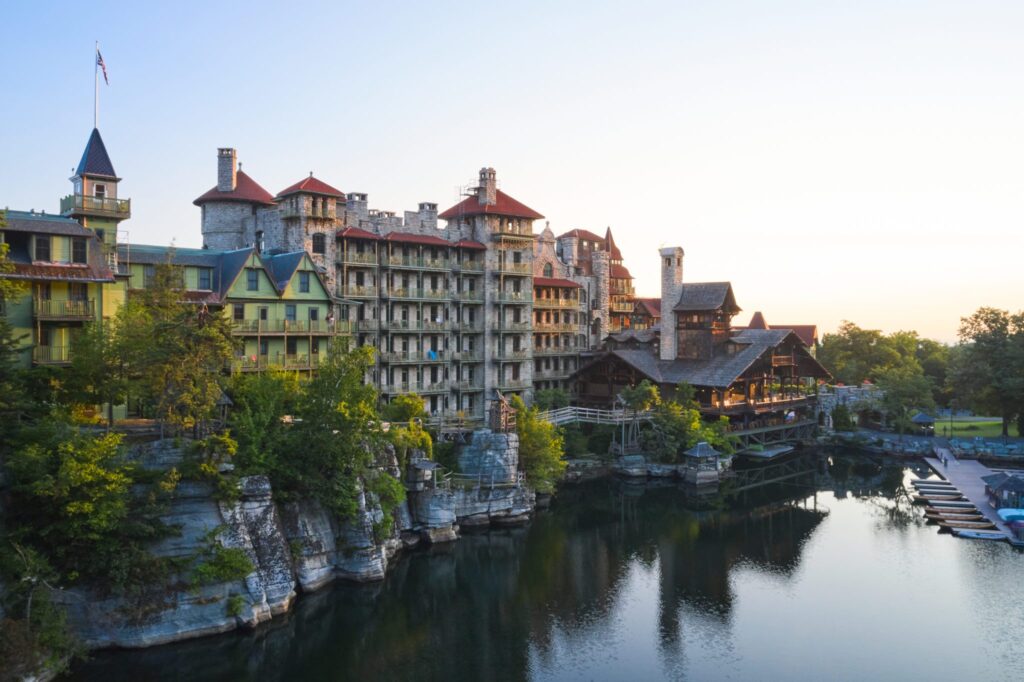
949,307,1024,436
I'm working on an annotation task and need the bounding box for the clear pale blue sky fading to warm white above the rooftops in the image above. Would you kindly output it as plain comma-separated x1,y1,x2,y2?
0,0,1024,342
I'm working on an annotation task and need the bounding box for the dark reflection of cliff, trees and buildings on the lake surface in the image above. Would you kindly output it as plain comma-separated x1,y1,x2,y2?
75,448,917,680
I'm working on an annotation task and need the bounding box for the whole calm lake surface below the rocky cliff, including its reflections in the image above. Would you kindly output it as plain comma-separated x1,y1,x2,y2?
74,450,1024,682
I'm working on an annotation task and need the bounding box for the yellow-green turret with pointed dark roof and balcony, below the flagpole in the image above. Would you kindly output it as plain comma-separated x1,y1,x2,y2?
60,128,131,259
